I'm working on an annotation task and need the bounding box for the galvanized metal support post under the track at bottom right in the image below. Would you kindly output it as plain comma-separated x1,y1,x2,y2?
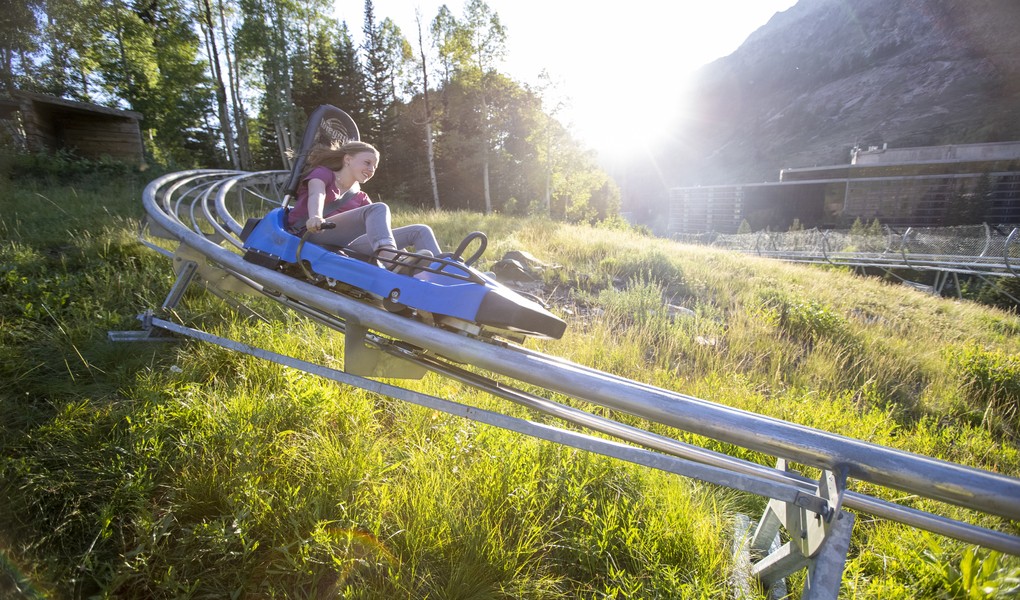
737,459,854,600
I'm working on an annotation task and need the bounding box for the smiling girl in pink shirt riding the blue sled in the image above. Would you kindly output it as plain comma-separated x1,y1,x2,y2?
287,142,442,264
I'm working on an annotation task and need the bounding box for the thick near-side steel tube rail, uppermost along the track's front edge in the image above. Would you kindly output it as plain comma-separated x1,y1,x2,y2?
143,171,1020,519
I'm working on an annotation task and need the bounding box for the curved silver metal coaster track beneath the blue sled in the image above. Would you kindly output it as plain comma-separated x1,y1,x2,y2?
142,170,1020,555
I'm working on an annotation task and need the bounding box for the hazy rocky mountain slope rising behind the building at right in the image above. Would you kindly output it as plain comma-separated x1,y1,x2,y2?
623,0,1020,222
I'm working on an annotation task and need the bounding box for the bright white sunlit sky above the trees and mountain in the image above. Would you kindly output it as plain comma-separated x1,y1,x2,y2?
336,0,797,158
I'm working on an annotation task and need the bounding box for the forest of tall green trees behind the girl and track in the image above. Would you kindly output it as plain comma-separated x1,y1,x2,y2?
0,0,620,222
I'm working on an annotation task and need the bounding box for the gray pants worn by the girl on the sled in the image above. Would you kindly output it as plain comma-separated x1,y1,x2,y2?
308,202,442,255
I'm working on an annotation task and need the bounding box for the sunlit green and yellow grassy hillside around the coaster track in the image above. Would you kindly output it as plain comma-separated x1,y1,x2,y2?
0,170,1020,599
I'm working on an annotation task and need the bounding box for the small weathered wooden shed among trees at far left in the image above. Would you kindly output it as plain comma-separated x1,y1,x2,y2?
5,92,145,166
